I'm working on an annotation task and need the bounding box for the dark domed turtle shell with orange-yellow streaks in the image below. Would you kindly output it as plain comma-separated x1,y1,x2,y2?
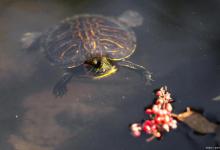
43,15,136,68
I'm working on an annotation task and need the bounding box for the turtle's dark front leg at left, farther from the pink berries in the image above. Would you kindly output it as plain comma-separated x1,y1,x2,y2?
53,71,74,96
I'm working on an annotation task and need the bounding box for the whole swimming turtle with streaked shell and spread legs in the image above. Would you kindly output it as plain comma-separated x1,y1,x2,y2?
21,10,152,96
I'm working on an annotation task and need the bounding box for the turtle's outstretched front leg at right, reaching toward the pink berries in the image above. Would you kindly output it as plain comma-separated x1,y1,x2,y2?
118,60,153,85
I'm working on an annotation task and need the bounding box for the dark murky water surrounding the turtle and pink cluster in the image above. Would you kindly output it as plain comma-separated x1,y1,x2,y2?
0,0,220,150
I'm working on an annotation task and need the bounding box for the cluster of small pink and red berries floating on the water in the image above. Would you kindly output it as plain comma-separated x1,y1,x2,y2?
130,87,177,141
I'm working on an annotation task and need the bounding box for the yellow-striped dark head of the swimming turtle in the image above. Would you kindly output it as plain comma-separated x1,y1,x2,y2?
85,56,118,79
